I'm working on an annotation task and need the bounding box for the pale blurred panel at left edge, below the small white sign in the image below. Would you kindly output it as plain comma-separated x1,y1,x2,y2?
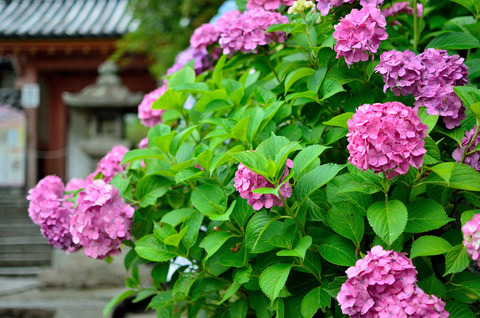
0,105,26,187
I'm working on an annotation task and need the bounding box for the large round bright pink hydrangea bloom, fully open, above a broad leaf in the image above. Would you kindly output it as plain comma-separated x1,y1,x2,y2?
347,102,428,179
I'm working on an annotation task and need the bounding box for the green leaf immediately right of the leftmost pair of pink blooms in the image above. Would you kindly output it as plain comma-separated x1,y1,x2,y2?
136,175,171,207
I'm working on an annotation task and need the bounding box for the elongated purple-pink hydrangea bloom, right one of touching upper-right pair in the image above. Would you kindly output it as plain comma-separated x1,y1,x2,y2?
414,49,468,129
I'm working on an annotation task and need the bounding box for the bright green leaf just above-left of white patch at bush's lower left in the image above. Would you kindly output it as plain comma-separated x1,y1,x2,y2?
135,234,177,262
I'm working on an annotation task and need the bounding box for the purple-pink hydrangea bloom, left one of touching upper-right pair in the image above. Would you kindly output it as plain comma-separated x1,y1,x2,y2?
375,50,423,96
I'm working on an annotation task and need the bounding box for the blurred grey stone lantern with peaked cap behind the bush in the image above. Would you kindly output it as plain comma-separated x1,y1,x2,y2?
62,61,143,177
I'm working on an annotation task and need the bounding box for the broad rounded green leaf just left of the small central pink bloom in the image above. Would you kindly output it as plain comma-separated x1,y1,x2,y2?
191,184,227,216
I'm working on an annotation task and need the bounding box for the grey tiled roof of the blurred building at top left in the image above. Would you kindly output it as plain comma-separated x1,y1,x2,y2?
0,0,137,38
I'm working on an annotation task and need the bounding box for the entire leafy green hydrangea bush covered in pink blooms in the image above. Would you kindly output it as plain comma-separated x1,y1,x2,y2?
29,0,480,318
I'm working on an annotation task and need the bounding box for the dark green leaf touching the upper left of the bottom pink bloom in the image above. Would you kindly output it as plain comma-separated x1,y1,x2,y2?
318,234,357,266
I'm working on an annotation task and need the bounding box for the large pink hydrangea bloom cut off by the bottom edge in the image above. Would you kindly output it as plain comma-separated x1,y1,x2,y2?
337,246,448,318
